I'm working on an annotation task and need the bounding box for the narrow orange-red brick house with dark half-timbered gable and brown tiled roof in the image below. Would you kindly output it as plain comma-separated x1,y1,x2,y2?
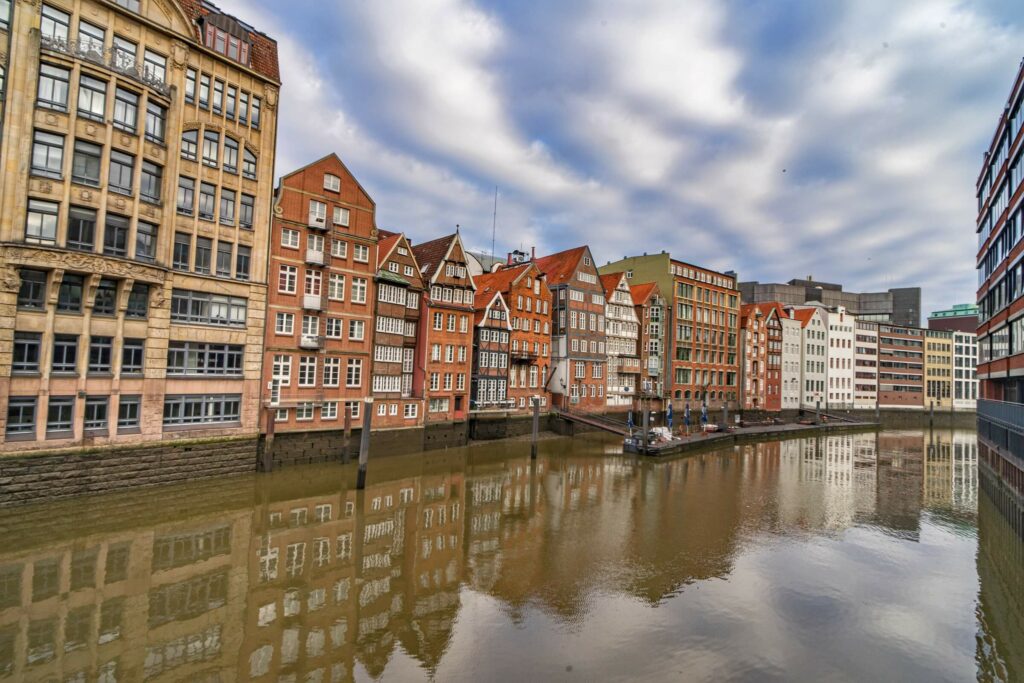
413,232,476,422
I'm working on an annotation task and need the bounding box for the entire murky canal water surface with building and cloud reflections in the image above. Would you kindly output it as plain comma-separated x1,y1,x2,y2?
0,431,1024,683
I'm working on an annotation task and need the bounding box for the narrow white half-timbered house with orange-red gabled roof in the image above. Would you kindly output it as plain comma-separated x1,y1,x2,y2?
601,272,640,408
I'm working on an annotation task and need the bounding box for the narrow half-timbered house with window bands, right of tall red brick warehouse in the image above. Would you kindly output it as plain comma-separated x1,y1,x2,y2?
371,230,425,428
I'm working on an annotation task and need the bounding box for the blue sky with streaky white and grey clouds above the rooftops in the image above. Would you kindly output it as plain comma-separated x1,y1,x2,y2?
216,0,1024,314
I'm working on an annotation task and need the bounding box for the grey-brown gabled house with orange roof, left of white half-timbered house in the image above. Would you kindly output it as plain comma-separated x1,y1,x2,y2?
535,246,606,412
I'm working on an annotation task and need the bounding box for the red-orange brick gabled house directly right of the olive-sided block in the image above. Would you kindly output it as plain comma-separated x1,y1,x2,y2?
739,303,785,411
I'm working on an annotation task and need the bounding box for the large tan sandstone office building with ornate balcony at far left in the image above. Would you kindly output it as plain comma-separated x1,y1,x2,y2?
0,0,280,452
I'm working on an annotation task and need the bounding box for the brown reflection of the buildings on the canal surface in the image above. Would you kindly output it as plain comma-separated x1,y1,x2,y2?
0,431,1011,682
